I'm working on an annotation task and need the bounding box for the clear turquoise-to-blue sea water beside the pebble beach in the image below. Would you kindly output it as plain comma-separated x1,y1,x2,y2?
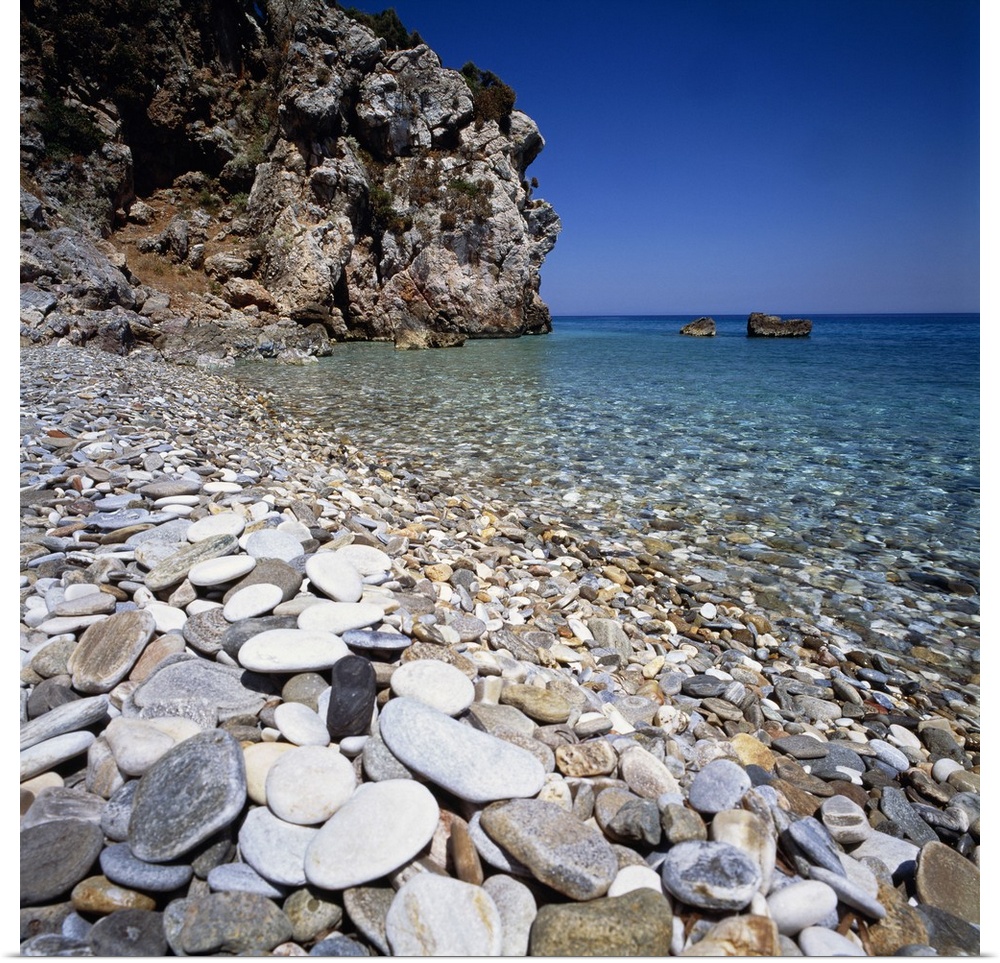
236,314,980,680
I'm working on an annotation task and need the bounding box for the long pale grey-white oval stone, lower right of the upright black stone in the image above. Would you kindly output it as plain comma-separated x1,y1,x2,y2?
379,697,545,802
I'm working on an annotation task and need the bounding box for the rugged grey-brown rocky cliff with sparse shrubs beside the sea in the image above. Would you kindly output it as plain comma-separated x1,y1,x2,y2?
21,0,560,363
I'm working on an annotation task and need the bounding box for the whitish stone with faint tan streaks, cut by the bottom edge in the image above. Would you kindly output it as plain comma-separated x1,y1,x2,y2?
385,873,503,956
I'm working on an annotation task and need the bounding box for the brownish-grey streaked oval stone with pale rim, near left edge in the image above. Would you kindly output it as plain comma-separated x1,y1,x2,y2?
67,609,156,695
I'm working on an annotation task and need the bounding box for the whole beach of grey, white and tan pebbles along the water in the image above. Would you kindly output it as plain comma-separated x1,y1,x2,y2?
20,347,980,956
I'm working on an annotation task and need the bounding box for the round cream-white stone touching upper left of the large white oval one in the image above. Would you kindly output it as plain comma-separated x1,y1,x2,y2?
265,746,358,826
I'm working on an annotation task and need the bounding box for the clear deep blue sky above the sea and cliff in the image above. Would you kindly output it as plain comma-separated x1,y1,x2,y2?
345,0,980,315
